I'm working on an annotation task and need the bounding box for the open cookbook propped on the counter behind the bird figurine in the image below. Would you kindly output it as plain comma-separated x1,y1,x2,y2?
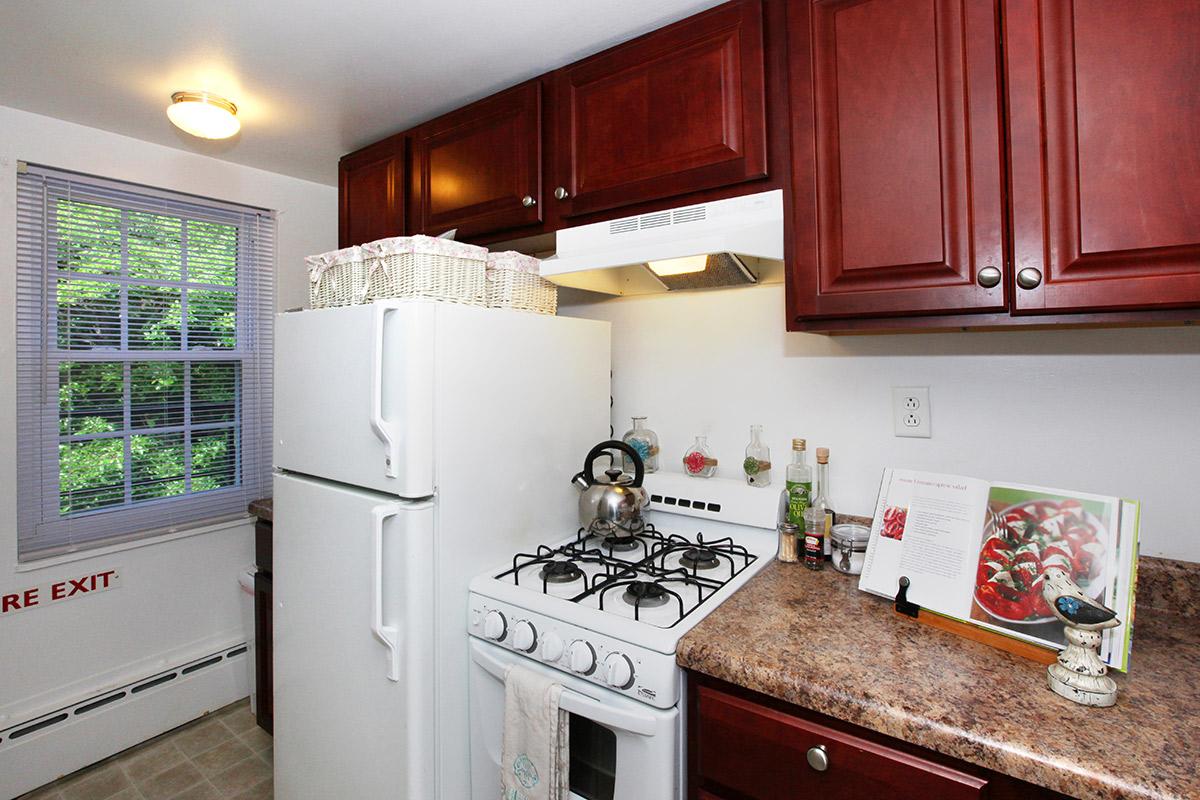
858,469,1139,672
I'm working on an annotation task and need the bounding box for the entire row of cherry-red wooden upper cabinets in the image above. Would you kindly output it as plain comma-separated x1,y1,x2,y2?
341,0,1200,331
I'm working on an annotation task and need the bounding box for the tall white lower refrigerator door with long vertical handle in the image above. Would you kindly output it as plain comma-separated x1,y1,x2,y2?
274,475,436,800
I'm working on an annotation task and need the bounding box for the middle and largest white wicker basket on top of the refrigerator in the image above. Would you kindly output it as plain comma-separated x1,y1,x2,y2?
362,236,487,306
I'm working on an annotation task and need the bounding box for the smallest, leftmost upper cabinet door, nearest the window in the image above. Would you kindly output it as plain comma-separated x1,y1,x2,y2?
337,137,404,247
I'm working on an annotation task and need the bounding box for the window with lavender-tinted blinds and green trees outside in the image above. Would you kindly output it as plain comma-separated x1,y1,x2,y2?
17,164,275,560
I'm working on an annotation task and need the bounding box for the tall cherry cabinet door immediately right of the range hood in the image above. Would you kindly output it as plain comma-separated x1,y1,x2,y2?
788,0,1007,318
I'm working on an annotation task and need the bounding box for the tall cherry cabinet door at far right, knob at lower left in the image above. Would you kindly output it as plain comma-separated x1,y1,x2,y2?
1004,0,1200,313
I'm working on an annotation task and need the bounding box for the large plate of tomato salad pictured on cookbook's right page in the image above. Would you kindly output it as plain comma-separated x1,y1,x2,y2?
974,499,1108,625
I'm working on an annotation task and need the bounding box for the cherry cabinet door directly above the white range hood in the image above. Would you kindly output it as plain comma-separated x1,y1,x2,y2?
553,0,767,216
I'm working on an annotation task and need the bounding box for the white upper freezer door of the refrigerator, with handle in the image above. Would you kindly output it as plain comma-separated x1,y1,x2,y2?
274,301,437,498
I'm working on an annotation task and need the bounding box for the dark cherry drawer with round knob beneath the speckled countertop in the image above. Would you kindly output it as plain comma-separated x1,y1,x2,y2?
692,686,988,800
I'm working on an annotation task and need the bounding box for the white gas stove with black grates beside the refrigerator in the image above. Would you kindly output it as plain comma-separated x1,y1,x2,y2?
468,474,779,800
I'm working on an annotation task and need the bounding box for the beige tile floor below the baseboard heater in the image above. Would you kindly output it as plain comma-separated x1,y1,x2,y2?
18,700,274,800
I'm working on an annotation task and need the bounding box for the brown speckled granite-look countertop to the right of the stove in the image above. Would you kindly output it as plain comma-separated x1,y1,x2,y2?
677,563,1200,800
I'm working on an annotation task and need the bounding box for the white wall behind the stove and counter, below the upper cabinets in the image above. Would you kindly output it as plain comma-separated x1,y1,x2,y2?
559,285,1200,561
